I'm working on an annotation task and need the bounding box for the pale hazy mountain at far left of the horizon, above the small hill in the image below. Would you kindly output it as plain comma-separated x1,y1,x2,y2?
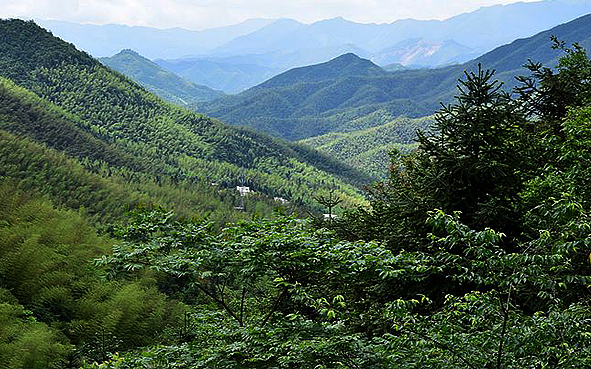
36,19,273,59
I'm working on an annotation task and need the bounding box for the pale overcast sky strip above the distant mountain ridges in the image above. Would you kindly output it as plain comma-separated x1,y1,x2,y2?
0,0,535,29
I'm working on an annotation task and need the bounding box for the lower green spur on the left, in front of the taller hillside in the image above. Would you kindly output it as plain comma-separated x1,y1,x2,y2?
0,77,290,223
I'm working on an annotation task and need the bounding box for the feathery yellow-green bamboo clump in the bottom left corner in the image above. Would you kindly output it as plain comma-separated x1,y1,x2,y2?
0,180,185,369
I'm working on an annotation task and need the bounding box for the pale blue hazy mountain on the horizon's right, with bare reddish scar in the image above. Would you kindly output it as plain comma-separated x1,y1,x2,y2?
207,0,591,66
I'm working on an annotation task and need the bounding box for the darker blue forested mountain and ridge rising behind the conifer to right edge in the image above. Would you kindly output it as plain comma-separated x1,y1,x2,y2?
205,15,591,140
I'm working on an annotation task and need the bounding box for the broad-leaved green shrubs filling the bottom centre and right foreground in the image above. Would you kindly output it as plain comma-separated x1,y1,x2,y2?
87,197,591,368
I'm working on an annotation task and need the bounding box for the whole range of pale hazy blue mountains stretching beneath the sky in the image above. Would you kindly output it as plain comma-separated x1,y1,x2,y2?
32,0,591,75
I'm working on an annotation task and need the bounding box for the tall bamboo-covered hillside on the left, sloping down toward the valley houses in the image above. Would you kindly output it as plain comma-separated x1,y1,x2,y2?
0,20,369,221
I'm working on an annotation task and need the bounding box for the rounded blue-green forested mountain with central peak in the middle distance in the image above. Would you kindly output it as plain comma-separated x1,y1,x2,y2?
203,54,412,139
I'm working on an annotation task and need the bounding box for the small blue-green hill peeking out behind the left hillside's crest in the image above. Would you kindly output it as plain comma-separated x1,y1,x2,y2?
99,49,224,106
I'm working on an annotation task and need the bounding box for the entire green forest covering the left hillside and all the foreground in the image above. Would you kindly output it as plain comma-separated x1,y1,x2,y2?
0,15,591,369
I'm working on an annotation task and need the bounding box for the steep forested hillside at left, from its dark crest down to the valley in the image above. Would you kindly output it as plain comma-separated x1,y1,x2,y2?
0,20,368,218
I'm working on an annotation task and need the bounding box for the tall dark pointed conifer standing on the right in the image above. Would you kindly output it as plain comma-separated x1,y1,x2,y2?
418,66,525,232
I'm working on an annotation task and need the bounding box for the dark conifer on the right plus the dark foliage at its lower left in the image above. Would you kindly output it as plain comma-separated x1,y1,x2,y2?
339,65,530,248
